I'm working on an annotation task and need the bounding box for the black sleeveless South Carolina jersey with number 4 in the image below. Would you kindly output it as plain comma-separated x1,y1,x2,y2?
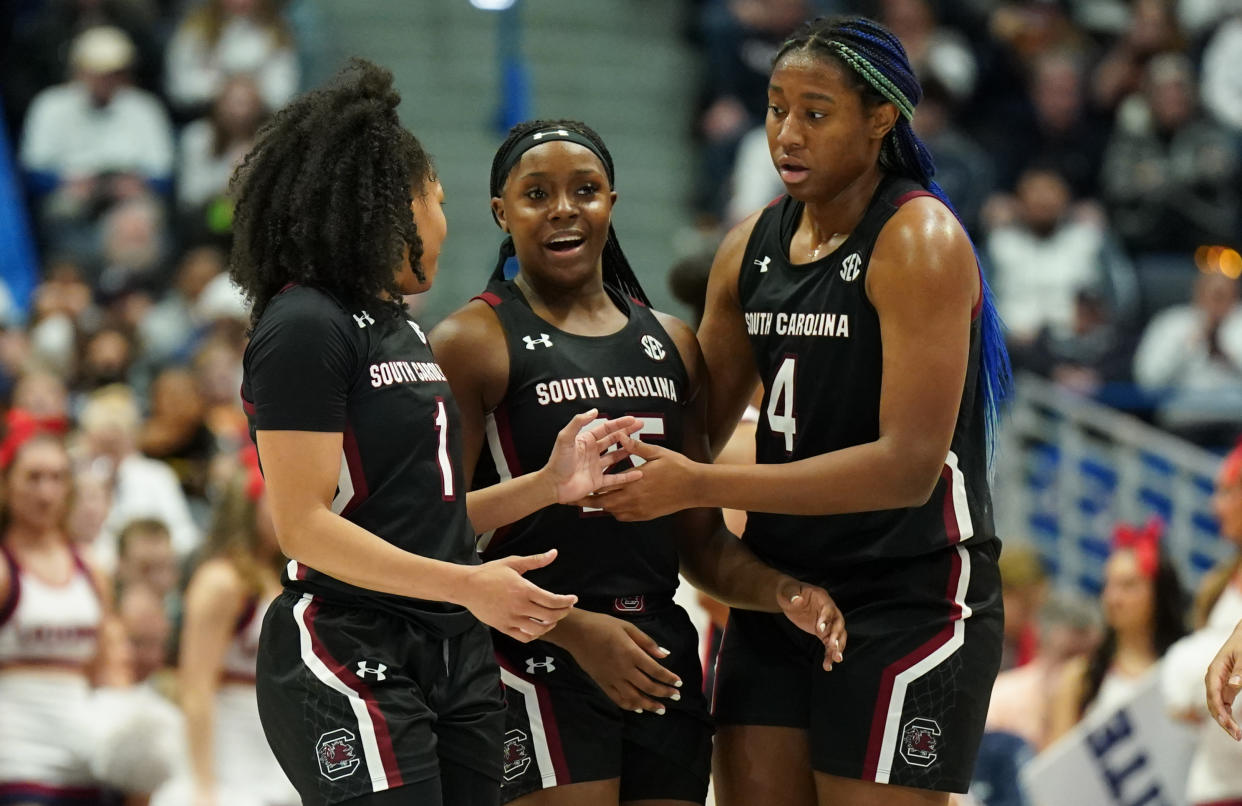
738,176,995,574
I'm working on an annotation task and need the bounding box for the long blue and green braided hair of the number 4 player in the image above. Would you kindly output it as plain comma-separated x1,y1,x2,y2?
773,16,1013,448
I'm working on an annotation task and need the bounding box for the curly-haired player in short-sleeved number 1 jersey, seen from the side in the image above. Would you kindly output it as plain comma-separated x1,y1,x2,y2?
232,61,638,806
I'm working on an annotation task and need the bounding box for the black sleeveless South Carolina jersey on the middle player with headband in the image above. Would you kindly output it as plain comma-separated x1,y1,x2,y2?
474,281,688,599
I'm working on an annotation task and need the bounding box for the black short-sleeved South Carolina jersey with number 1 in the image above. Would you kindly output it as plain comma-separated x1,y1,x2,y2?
241,286,478,635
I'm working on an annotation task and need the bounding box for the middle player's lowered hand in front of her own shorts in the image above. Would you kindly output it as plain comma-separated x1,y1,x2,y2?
546,610,682,714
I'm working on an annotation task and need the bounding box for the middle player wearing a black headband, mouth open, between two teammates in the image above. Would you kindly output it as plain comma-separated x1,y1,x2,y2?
431,120,845,806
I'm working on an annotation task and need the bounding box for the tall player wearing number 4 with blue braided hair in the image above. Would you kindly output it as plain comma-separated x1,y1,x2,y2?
600,17,1007,806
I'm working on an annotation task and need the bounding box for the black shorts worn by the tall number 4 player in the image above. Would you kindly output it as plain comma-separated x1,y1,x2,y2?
713,540,1004,792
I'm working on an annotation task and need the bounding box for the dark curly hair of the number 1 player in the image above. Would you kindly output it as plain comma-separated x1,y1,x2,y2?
230,58,435,323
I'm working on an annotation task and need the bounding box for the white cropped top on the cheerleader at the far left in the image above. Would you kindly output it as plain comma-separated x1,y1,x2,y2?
0,545,103,668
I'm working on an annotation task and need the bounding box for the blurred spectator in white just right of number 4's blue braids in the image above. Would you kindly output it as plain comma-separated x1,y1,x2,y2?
986,168,1135,346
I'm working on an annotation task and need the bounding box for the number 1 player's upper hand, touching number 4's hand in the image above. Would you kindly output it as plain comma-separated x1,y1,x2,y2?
544,409,642,504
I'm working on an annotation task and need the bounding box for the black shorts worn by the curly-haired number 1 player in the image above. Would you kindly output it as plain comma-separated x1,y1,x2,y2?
256,591,504,805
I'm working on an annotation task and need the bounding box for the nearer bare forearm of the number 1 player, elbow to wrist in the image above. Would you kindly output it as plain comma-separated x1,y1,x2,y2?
277,508,471,604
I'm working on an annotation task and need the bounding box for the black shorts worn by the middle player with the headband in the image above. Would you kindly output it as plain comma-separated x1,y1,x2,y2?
492,596,713,804
